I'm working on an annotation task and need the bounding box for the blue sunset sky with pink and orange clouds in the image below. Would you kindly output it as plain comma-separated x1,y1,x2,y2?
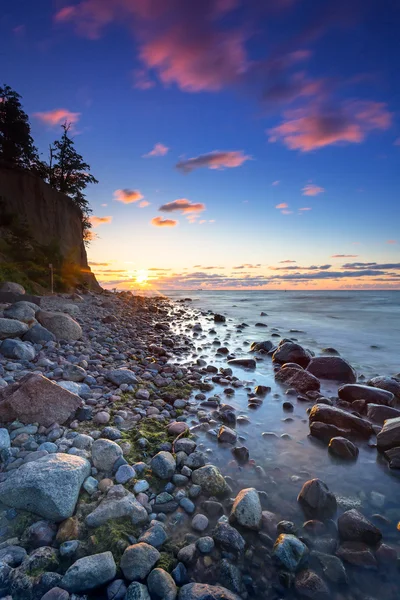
0,0,400,290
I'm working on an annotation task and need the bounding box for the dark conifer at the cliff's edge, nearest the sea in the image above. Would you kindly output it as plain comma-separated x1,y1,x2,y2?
47,123,98,241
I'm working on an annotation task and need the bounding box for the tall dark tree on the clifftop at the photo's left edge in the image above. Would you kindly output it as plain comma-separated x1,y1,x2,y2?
0,85,43,175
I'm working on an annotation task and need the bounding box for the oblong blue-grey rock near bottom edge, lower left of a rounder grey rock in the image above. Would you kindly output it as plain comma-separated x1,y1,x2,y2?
61,552,117,593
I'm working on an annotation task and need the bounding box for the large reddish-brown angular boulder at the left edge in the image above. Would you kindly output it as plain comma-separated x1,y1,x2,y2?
0,374,82,427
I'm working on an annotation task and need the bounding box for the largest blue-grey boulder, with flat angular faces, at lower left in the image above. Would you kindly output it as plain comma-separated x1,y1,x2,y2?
0,453,90,522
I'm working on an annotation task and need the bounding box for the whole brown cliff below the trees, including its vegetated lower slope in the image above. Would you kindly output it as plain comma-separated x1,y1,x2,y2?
0,168,100,290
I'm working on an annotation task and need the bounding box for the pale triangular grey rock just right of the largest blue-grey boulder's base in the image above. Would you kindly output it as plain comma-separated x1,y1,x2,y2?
85,485,148,527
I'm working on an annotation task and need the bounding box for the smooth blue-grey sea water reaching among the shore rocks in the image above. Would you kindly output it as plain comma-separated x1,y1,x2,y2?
163,291,400,600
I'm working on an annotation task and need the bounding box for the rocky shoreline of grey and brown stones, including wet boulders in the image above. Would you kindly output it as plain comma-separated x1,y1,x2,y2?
0,284,400,600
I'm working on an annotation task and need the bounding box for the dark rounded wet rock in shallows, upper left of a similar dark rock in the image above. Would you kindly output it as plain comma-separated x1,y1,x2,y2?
297,479,337,521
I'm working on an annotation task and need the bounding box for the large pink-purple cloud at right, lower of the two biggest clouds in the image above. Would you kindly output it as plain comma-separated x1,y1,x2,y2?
268,101,392,152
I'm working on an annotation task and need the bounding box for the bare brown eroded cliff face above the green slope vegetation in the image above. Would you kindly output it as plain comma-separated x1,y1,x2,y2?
0,168,99,287
